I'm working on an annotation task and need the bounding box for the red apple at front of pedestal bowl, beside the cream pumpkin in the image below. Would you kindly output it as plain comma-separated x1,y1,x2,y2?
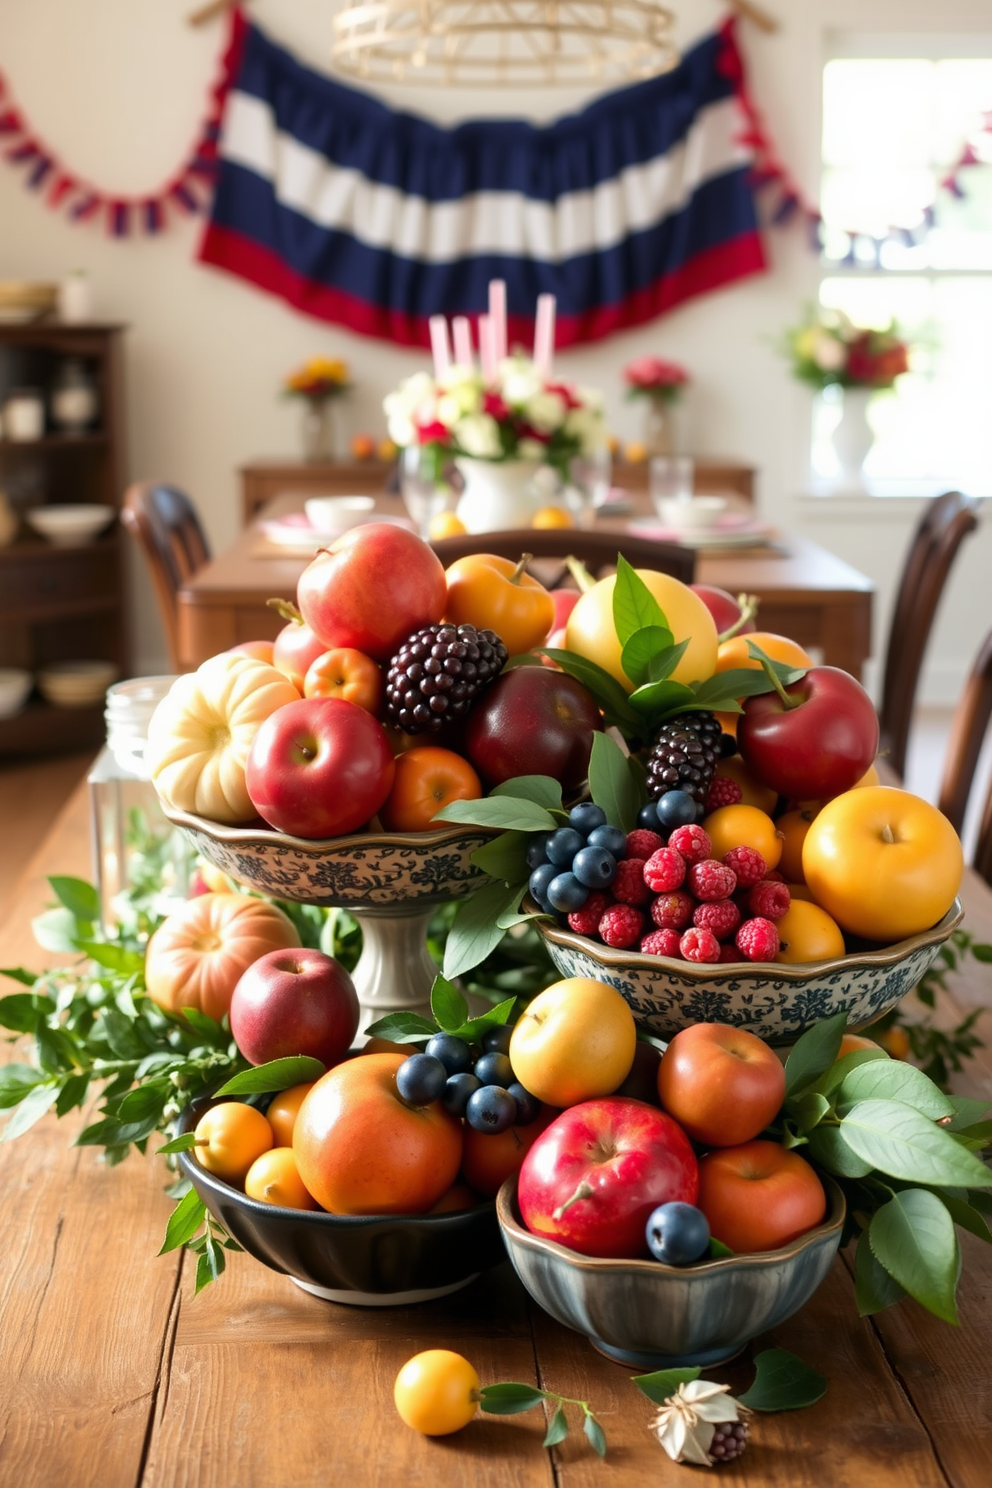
245,698,396,838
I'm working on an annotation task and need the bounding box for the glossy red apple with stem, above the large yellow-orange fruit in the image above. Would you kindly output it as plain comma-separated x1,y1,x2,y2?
738,667,879,801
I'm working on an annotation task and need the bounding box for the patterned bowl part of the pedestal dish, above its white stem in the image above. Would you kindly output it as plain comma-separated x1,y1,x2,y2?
162,802,492,909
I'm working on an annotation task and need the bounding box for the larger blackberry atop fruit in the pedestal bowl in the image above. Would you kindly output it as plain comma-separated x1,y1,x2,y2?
385,625,509,734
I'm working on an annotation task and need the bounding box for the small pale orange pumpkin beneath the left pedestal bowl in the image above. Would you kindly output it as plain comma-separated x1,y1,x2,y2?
144,894,300,1021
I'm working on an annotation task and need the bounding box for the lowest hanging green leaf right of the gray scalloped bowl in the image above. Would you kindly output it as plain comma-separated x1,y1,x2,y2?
869,1189,961,1323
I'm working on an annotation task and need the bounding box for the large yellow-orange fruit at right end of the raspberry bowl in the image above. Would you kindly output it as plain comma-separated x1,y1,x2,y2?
803,786,964,943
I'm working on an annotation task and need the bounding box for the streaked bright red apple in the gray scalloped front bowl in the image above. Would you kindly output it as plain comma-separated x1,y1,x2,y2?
518,1095,699,1260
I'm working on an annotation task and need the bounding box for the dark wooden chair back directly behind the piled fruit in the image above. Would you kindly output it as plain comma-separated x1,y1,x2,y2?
431,527,696,589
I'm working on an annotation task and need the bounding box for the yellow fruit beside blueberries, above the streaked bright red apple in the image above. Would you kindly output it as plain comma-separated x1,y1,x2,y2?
510,976,637,1106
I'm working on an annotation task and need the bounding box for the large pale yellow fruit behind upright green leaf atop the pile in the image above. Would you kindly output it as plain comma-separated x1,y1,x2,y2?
565,568,717,692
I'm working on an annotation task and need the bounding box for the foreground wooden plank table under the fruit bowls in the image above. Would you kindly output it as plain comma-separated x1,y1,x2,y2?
0,792,992,1488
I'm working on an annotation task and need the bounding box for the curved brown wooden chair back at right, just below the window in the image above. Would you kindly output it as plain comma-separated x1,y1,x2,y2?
879,491,980,775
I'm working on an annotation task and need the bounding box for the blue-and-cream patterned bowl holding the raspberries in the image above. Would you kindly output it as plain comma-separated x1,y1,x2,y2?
525,899,964,1045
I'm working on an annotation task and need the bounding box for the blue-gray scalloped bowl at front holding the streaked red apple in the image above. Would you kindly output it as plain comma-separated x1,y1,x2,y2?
497,1177,845,1369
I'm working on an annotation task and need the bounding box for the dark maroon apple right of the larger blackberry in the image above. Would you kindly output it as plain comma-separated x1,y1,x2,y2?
466,667,602,789
